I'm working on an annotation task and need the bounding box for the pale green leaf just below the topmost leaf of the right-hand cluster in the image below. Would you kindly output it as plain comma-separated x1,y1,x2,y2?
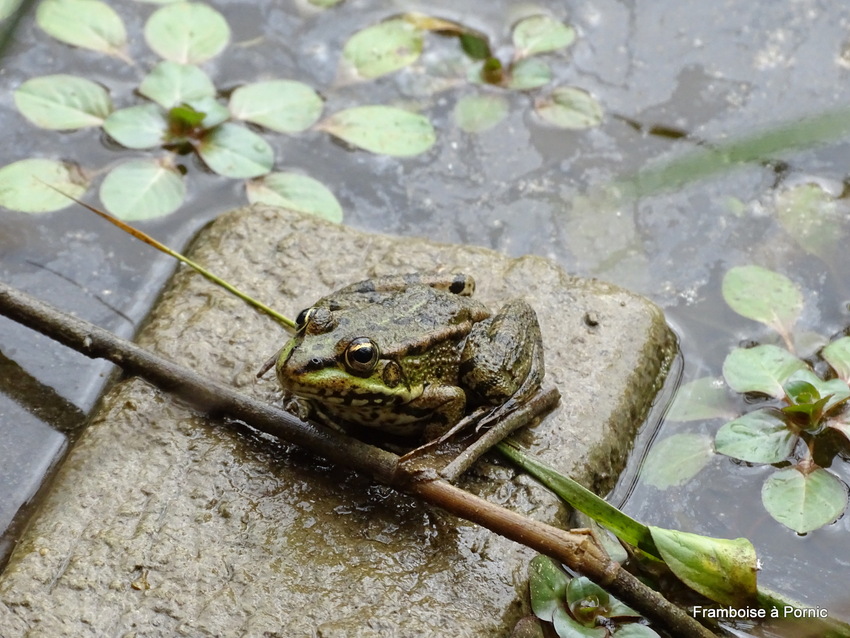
723,344,808,399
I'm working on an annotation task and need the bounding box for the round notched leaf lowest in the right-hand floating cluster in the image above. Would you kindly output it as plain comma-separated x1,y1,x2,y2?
761,467,847,534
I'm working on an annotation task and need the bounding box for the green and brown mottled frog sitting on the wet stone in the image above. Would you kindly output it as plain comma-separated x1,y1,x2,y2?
275,273,544,441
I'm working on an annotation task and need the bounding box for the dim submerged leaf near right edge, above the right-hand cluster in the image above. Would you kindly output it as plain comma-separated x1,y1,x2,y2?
776,184,847,259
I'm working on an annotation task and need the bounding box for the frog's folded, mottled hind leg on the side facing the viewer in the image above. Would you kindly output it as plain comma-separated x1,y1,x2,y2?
460,299,544,420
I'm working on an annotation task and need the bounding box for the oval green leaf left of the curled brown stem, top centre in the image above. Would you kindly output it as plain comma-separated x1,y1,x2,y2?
342,18,423,78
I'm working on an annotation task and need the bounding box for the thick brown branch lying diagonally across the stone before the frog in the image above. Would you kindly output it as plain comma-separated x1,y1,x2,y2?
0,282,714,638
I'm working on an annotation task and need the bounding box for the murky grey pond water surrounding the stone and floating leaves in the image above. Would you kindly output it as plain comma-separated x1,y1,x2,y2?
0,0,850,632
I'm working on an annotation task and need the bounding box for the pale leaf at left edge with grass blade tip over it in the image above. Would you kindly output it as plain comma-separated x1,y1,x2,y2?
0,158,89,213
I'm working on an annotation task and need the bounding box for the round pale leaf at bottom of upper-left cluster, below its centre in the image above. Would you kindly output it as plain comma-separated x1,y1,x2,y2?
100,160,186,221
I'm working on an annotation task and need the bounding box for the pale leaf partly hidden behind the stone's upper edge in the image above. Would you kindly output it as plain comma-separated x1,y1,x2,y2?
246,173,342,223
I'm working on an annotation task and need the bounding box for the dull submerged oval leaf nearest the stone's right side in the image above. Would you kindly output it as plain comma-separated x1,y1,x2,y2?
640,433,713,490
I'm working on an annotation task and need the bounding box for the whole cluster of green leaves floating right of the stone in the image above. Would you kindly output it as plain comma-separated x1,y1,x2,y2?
656,266,850,534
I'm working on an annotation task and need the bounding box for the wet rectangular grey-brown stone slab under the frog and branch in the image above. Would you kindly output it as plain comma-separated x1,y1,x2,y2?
0,208,674,638
